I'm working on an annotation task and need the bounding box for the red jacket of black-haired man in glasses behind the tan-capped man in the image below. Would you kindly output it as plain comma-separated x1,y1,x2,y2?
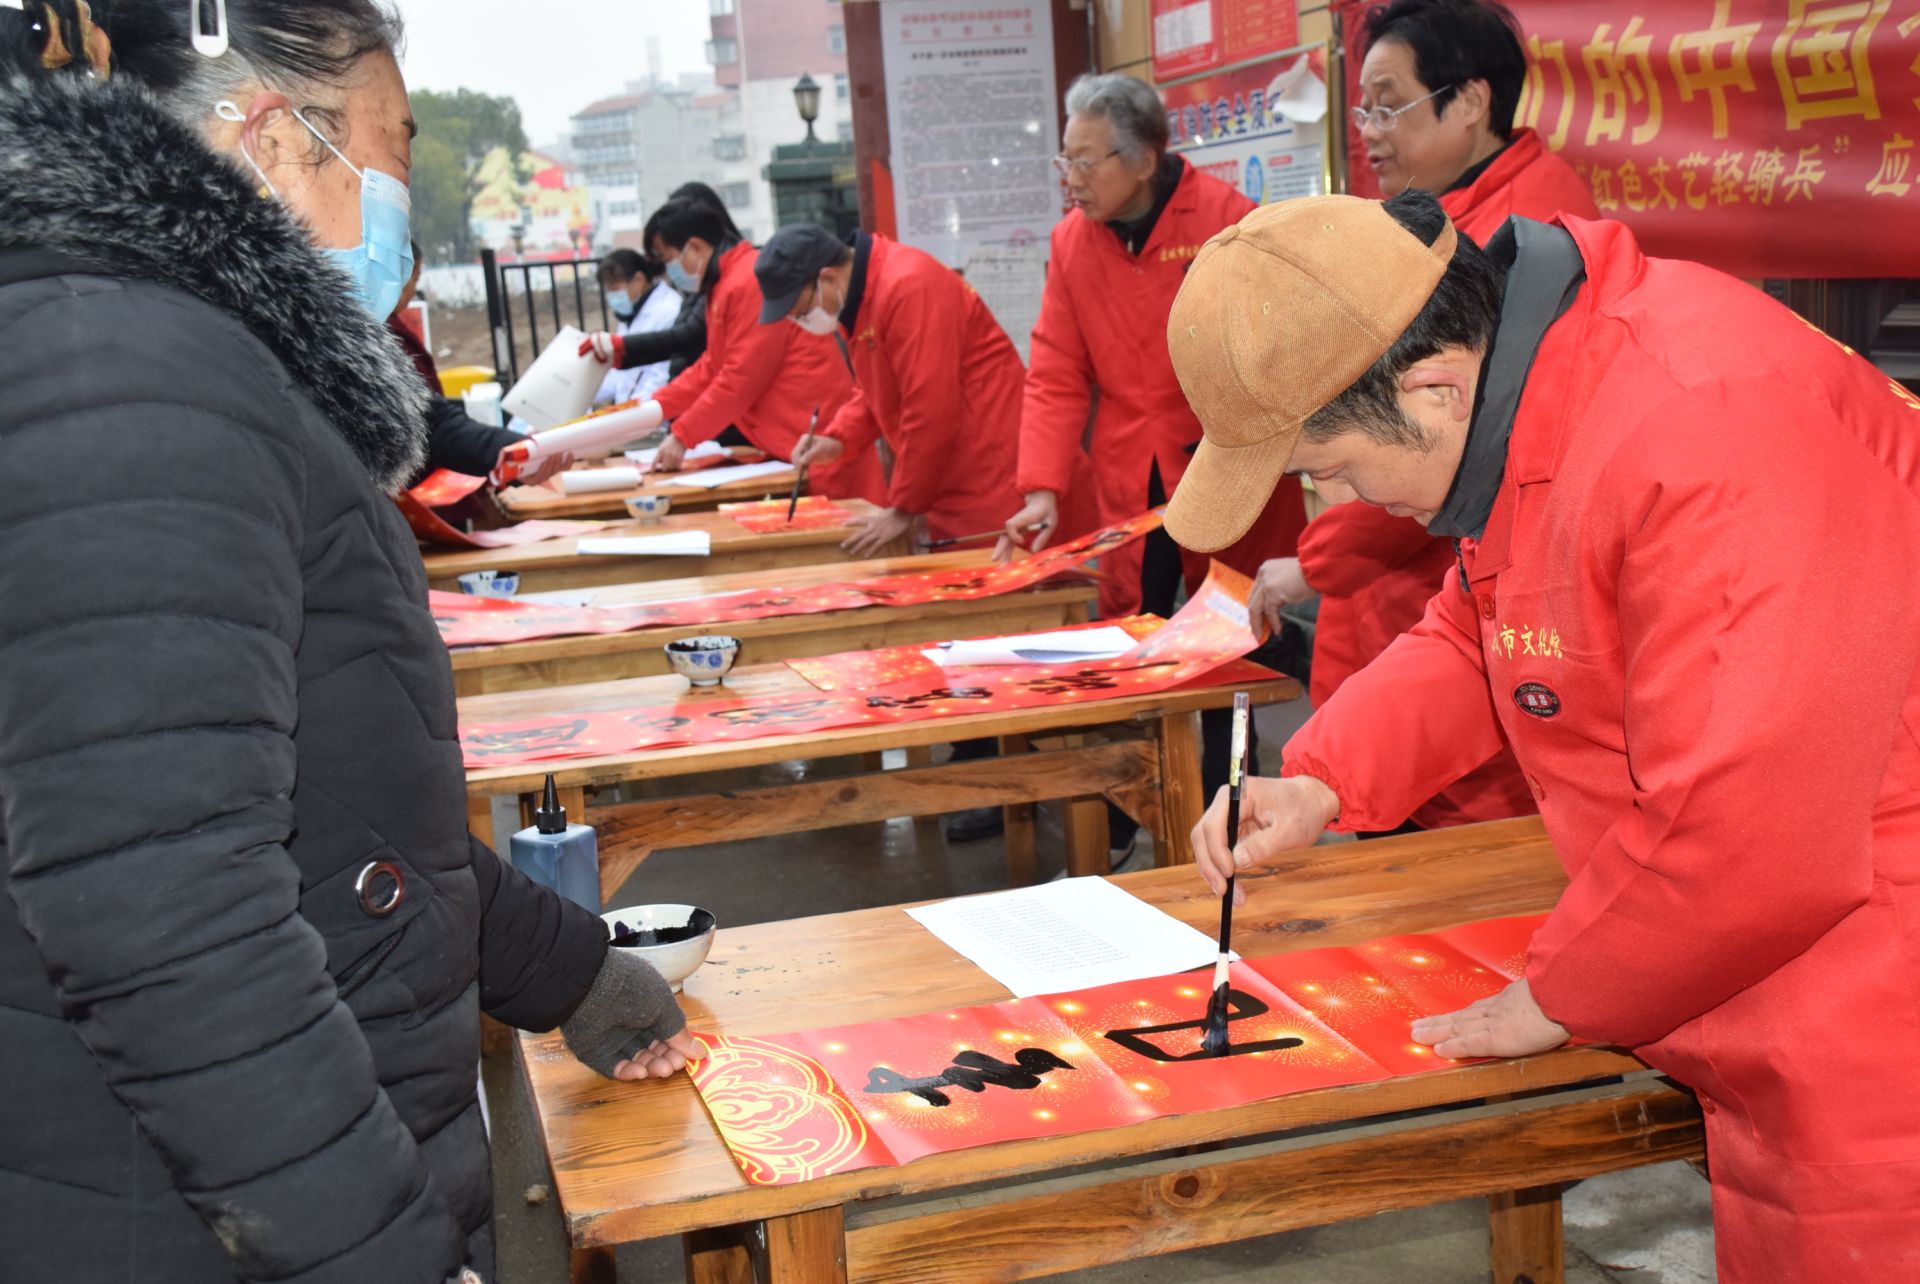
1300,129,1599,829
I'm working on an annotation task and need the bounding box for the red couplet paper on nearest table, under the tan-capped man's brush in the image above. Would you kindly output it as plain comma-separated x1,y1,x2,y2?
687,915,1546,1186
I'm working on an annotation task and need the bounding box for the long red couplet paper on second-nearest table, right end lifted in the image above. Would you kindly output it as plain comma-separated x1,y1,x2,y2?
461,564,1275,770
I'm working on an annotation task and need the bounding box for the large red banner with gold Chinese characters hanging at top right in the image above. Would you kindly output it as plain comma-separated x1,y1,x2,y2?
1336,0,1920,276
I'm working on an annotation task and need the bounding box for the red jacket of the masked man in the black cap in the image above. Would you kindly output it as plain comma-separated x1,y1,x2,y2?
826,236,1027,539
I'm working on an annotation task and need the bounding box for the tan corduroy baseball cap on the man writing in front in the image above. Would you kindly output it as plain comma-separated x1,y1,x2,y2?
1167,196,1455,553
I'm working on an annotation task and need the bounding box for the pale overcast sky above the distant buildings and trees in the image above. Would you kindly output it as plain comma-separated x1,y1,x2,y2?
394,0,708,146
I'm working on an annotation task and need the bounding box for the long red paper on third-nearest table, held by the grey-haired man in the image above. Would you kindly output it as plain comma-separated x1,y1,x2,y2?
428,509,1159,647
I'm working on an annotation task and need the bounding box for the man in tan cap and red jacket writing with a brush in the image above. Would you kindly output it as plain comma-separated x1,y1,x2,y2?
1167,192,1920,1284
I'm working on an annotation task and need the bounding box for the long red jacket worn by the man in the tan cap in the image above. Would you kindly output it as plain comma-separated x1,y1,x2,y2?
1284,221,1920,1284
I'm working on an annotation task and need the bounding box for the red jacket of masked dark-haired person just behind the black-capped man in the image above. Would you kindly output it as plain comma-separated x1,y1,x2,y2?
657,244,887,503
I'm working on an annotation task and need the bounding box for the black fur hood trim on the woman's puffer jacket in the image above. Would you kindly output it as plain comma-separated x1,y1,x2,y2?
0,77,426,493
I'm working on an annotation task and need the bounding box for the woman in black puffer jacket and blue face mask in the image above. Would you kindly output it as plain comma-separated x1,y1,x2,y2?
0,0,689,1284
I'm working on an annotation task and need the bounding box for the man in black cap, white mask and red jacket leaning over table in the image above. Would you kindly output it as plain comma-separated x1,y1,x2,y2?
755,223,1085,557
